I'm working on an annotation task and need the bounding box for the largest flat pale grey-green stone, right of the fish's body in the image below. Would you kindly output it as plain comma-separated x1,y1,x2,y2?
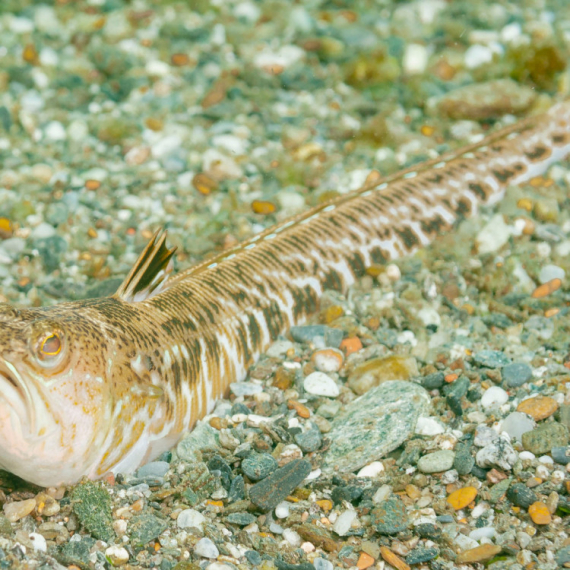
321,381,431,473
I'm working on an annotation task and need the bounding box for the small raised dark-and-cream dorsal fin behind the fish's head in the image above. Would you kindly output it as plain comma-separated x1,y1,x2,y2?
114,230,176,303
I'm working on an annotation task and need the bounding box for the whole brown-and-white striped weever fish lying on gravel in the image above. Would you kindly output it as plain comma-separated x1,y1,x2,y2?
0,101,570,486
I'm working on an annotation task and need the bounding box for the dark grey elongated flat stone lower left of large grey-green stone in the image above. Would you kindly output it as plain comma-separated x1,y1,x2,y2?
249,459,312,511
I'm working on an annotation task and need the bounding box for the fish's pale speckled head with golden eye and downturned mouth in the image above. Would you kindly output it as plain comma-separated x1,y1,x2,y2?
0,303,114,486
